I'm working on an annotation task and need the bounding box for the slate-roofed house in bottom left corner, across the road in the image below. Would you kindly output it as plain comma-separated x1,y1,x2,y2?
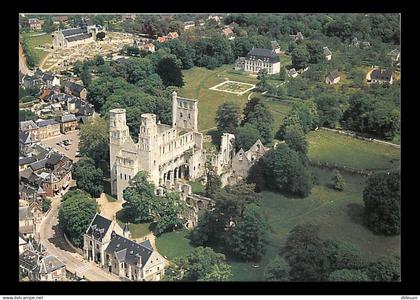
19,250,67,281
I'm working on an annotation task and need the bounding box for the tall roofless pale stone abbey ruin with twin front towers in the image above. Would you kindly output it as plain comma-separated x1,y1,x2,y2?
109,92,205,199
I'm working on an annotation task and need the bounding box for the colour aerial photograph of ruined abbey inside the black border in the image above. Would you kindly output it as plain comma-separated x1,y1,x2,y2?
15,12,401,285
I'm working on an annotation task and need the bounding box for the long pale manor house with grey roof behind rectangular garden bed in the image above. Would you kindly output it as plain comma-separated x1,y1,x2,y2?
236,48,280,75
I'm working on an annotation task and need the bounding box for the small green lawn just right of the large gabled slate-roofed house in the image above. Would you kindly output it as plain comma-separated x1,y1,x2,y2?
156,229,194,260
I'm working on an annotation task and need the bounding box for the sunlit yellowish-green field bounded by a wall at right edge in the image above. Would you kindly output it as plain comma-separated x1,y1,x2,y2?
307,130,401,170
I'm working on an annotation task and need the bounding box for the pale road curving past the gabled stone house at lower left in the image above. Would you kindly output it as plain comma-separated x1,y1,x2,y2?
40,197,121,281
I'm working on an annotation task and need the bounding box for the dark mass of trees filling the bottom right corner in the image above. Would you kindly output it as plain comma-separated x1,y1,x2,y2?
265,224,401,281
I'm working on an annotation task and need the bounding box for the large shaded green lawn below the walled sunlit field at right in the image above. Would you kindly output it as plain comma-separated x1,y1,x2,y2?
230,169,400,281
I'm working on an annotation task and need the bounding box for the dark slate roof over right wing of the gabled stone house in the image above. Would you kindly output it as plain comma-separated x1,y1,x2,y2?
105,231,153,265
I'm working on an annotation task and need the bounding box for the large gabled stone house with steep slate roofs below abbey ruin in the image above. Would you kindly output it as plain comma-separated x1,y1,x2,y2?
83,213,165,281
